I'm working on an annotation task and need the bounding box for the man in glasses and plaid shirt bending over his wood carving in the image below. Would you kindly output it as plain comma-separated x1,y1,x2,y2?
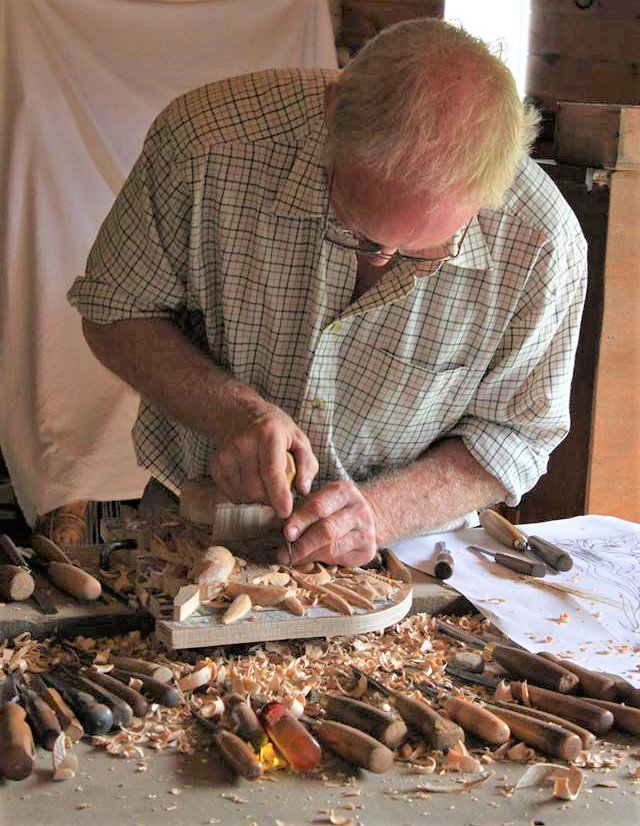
70,20,586,565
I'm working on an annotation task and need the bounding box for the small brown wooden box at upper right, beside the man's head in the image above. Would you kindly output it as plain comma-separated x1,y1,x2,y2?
555,101,640,170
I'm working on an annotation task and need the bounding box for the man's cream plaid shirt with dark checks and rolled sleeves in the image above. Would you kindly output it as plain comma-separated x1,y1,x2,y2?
69,70,586,520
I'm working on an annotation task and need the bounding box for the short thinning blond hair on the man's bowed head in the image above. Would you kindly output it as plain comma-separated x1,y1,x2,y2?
327,18,538,206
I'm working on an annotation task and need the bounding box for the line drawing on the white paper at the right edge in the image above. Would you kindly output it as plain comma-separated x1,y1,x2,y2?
556,533,640,634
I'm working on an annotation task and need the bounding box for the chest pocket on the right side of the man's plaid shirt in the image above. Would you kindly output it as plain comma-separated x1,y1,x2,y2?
333,349,477,479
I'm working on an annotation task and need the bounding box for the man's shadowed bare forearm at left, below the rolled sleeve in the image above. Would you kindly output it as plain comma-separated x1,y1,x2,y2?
83,318,262,440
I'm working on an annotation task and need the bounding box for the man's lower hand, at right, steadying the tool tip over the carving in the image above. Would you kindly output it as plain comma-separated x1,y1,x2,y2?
280,481,376,568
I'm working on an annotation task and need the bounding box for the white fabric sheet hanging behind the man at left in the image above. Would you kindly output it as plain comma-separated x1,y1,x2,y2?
0,0,336,521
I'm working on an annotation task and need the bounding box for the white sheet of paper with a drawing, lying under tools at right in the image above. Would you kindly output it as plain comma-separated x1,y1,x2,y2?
393,516,640,686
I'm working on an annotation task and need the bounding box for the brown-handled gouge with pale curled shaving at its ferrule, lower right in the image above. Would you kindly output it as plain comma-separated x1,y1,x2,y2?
446,663,613,734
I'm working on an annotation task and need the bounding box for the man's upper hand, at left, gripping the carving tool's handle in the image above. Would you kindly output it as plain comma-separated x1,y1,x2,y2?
211,400,318,519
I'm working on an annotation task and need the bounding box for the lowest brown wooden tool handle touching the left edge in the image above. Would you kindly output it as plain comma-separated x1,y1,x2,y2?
0,675,36,780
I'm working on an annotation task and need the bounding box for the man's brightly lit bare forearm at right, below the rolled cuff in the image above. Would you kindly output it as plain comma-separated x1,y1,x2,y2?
362,439,506,547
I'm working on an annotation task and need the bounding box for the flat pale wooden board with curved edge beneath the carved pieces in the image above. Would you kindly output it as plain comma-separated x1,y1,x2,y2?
156,584,413,648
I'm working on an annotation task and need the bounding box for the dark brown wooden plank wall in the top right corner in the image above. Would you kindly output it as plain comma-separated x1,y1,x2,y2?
526,0,640,109
